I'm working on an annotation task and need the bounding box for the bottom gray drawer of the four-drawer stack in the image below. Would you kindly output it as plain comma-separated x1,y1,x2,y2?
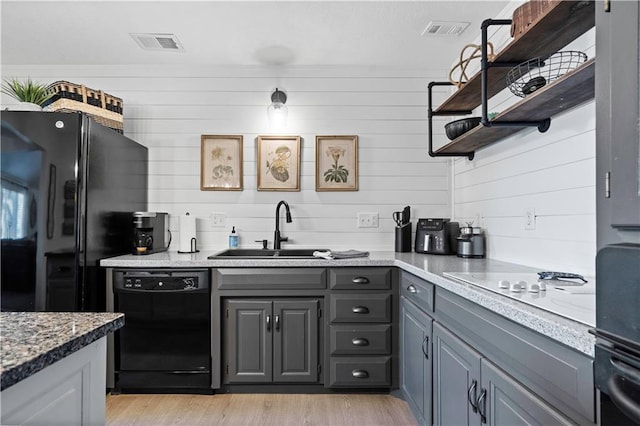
329,356,391,388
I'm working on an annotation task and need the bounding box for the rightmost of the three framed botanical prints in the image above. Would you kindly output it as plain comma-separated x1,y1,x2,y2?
316,135,358,192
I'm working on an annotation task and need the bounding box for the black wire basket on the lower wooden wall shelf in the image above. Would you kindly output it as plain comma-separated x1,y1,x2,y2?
506,50,587,98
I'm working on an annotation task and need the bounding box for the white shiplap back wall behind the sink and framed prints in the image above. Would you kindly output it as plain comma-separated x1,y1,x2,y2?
2,66,451,250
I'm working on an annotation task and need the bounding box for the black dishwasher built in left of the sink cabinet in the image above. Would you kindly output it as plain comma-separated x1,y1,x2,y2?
113,269,211,393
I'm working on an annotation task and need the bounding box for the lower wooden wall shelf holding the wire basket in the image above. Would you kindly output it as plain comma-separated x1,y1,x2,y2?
435,59,595,154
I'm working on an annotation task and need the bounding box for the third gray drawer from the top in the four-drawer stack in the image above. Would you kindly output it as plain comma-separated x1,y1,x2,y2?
329,325,391,355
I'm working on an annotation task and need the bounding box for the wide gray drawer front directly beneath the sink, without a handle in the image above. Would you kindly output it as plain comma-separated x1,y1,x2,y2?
212,268,327,290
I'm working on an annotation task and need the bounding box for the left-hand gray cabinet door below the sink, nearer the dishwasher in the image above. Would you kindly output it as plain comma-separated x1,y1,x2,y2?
223,299,273,383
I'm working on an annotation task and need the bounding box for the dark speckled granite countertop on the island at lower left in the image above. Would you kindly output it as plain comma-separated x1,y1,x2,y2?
0,312,124,390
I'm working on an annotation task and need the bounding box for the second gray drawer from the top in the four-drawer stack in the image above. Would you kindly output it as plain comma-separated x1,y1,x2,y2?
330,293,391,322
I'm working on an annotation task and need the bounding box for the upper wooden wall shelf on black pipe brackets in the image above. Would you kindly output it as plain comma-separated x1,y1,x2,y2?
435,0,595,112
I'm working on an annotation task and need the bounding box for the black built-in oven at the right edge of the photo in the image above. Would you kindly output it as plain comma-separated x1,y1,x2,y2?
593,244,640,426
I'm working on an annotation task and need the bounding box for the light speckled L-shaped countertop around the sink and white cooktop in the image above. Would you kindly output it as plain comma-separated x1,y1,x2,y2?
100,251,595,357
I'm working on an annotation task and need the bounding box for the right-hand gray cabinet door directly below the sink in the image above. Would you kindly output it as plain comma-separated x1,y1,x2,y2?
273,299,319,383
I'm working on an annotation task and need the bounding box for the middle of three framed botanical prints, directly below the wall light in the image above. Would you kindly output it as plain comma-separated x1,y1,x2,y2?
257,136,301,191
